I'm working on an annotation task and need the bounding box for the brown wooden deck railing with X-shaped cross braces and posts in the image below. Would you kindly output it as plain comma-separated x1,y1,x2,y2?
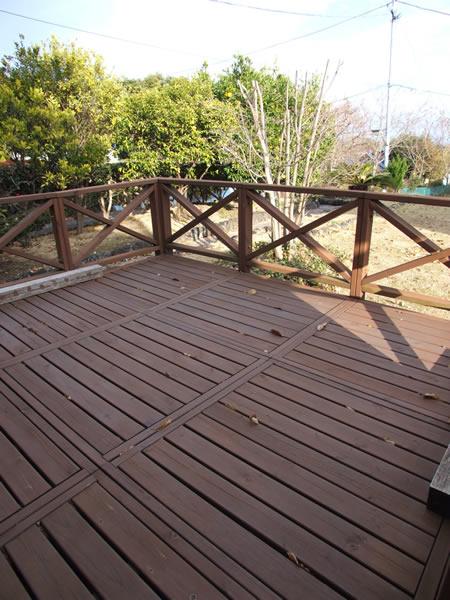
0,178,450,309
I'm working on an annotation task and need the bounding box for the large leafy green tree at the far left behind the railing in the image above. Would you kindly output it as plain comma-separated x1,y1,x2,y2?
0,38,120,191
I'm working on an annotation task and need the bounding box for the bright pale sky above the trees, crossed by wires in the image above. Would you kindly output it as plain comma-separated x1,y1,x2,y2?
0,0,450,116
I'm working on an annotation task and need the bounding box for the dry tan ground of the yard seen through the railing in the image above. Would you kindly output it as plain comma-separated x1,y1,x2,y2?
0,203,450,319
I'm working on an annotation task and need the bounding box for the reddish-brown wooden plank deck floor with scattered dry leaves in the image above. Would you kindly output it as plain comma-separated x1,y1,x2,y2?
0,256,450,600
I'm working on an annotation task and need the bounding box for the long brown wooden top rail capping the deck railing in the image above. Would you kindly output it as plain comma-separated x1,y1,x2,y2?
0,177,450,207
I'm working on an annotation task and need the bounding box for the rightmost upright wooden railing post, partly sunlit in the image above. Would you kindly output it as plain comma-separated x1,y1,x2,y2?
350,198,373,298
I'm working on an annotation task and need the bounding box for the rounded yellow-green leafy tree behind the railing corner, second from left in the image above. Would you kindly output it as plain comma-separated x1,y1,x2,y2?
115,72,233,178
